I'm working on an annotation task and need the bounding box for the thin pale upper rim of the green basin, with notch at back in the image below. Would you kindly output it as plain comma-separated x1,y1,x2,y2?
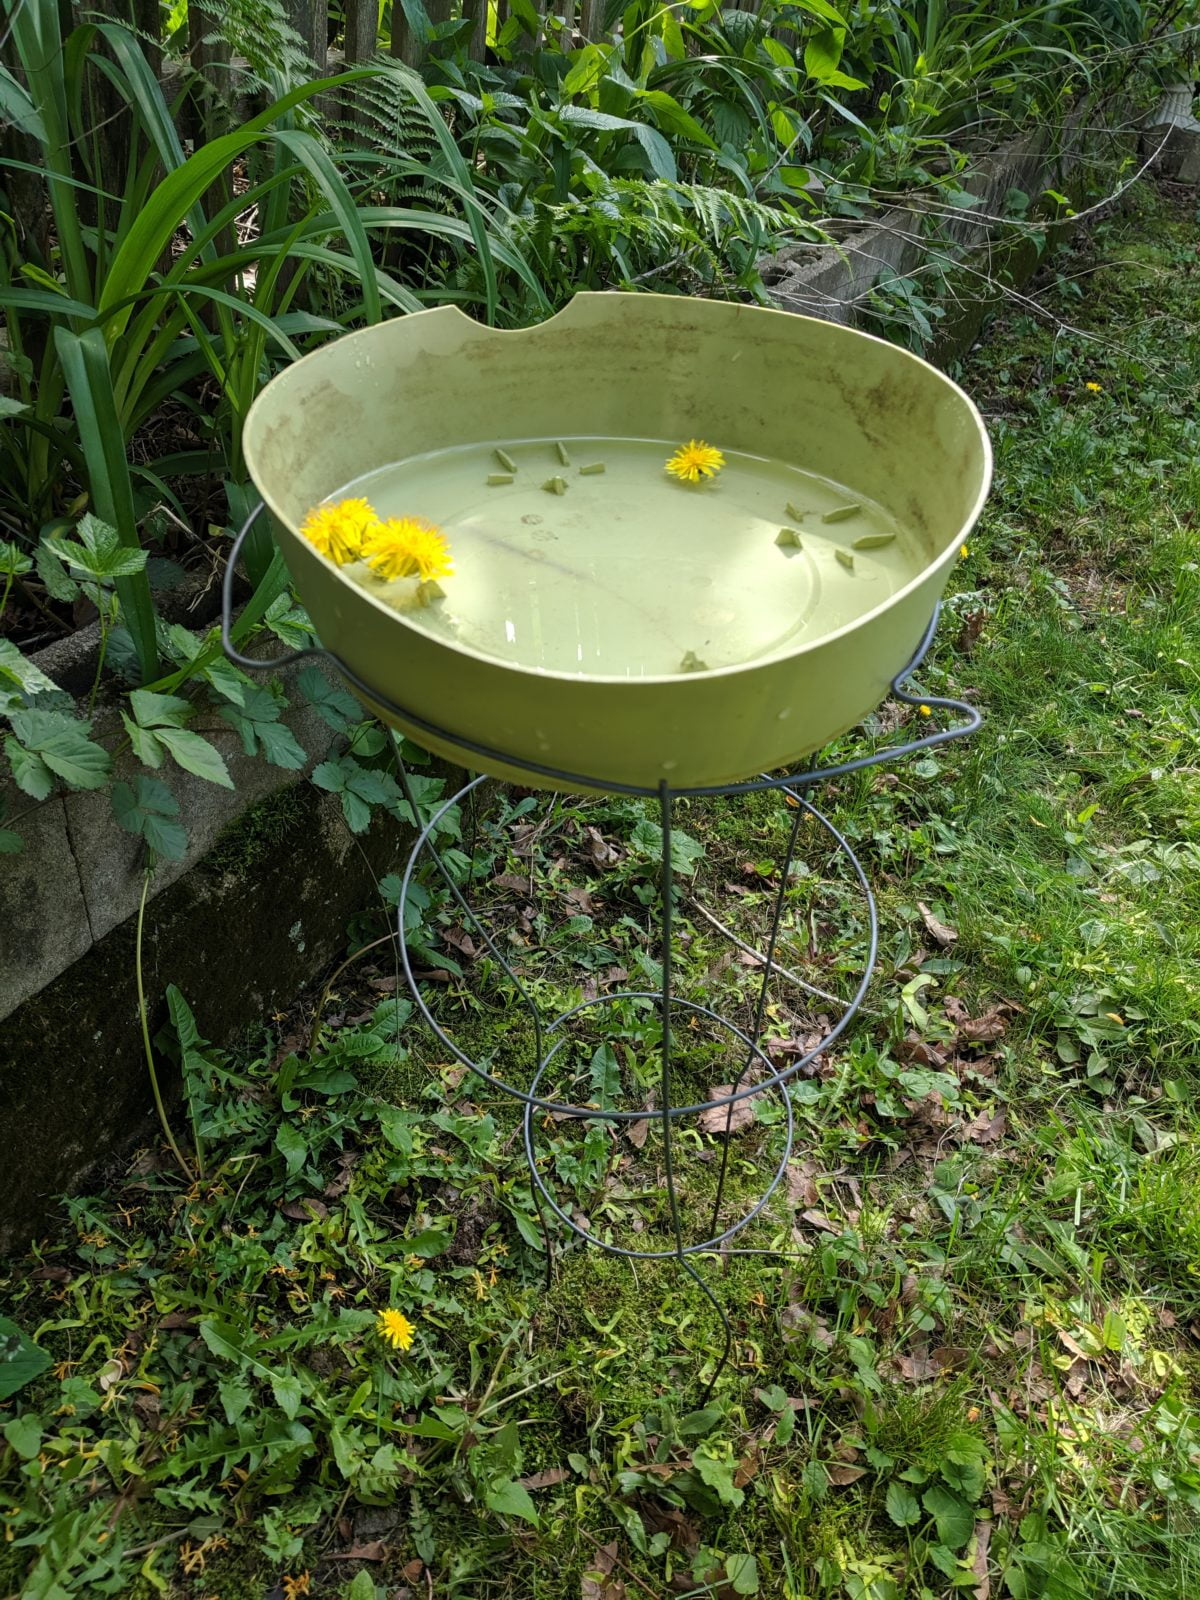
242,290,995,690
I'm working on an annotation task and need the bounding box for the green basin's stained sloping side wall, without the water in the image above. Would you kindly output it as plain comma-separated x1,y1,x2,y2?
246,294,990,789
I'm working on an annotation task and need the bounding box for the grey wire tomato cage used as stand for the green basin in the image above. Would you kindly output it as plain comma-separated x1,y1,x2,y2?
221,504,982,1405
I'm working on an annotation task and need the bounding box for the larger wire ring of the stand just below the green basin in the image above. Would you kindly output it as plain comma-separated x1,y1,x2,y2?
397,776,878,1122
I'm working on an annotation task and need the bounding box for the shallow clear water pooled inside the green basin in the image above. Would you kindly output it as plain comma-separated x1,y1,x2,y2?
330,437,928,678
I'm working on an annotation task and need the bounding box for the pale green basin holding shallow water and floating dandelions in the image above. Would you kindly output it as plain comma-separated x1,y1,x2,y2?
245,294,990,789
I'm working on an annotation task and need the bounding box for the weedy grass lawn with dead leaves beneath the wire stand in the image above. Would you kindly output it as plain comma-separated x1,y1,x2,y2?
0,175,1200,1600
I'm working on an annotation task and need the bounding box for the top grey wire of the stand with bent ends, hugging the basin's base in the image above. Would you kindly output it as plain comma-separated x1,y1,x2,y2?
221,501,984,798
